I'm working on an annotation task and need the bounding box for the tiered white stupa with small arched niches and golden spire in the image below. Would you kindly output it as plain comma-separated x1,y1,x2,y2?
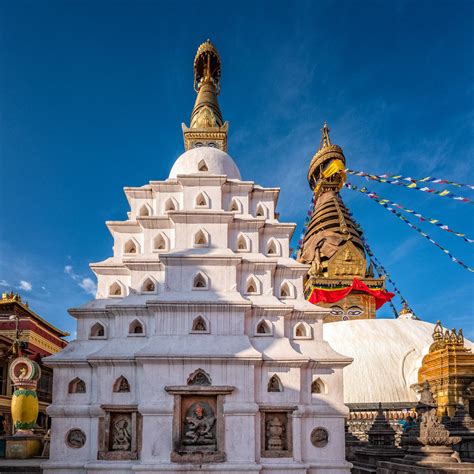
44,42,351,474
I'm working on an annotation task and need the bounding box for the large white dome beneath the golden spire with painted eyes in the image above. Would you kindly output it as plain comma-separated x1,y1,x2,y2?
323,319,473,403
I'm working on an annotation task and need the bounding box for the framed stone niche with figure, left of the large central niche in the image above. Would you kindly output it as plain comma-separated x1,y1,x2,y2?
97,405,142,461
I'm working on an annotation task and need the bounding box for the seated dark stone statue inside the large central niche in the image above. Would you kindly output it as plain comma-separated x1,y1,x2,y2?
183,402,217,447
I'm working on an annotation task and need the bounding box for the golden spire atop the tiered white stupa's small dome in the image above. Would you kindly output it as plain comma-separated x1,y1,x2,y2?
183,39,228,151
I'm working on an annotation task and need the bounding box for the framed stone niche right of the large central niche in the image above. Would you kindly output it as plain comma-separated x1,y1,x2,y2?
260,407,297,458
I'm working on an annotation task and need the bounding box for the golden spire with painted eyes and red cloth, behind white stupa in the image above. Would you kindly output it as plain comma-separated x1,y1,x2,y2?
298,123,390,322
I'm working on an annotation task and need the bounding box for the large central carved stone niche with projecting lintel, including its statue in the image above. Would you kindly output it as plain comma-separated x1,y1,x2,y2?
165,377,235,464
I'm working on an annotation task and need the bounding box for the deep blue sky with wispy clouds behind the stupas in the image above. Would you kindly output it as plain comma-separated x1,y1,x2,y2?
0,0,474,339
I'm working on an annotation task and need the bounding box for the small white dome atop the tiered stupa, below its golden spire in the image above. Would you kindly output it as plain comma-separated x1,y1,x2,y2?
169,146,241,180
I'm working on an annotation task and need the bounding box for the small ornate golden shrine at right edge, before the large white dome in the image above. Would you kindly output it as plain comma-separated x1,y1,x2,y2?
418,321,474,417
